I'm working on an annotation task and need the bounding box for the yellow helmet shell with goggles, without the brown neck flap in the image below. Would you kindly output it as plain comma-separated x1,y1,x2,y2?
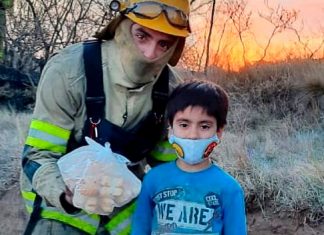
110,0,190,37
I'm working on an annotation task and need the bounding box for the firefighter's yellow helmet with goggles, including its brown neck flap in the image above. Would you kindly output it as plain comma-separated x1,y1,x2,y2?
94,0,190,66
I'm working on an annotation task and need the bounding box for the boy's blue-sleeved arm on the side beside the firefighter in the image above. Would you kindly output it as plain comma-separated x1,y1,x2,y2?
131,174,154,235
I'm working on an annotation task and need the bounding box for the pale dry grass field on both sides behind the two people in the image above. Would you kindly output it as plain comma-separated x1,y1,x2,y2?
0,58,324,228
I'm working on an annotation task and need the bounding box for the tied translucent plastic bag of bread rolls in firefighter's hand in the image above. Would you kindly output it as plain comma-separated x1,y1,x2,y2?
57,137,141,215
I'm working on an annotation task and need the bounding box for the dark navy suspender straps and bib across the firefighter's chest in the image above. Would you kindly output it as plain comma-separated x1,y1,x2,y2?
81,40,169,162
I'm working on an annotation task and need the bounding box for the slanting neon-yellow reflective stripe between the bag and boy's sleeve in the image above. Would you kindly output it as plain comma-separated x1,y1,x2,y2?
105,201,135,231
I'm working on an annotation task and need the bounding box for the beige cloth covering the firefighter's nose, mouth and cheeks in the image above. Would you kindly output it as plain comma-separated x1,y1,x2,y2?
114,19,177,86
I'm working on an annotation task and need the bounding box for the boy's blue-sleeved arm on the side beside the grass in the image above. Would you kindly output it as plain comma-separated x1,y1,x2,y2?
223,185,247,235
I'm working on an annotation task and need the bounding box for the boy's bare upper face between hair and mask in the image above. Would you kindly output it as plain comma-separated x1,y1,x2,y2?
171,106,220,139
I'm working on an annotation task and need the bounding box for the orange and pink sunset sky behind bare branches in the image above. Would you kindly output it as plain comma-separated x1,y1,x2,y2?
193,0,324,69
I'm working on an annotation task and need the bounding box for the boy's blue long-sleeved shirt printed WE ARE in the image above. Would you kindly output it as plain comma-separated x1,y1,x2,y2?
131,161,246,235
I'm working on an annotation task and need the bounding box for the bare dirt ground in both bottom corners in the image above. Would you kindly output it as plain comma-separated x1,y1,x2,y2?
0,183,324,235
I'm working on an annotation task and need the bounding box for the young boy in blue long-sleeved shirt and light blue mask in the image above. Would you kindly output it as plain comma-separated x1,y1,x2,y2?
131,81,246,235
